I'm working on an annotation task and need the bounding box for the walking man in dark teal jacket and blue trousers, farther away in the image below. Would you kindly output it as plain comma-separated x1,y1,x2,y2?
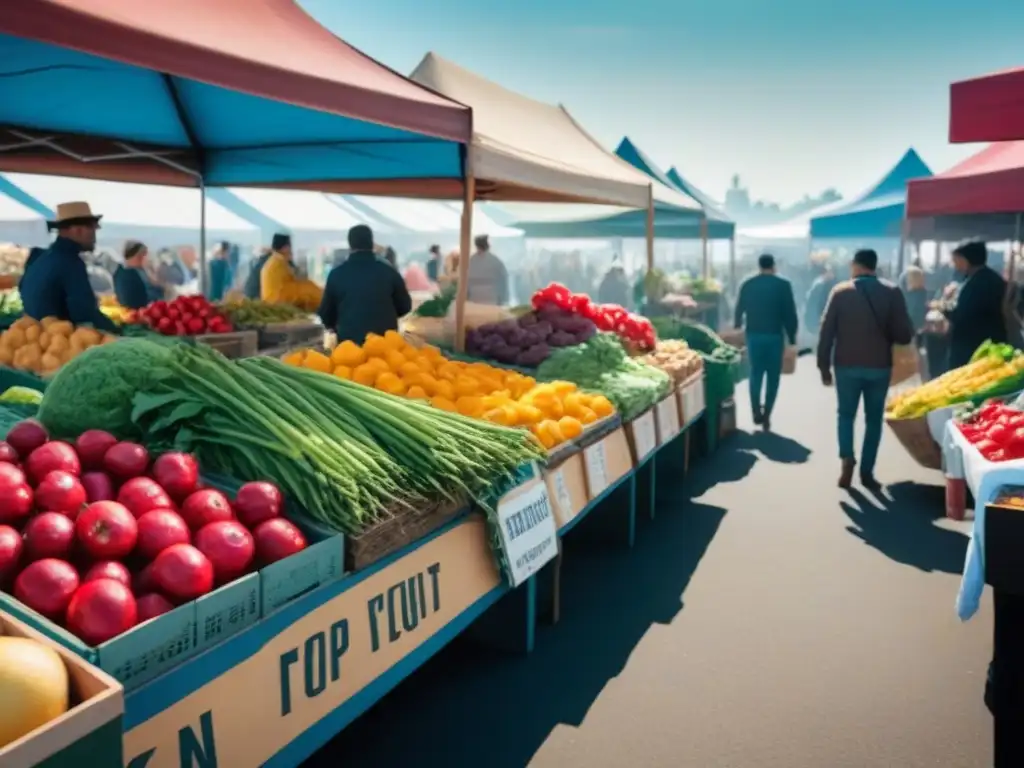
735,253,797,430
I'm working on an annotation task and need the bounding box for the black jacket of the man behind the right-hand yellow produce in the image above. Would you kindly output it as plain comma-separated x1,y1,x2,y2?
945,266,1007,369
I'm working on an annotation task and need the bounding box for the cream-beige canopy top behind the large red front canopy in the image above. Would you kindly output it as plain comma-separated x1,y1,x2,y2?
411,53,699,211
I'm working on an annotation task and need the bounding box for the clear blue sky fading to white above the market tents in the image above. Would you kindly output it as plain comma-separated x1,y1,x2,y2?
300,0,1024,203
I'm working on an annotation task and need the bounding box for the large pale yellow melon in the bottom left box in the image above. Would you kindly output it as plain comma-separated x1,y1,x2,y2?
0,637,70,750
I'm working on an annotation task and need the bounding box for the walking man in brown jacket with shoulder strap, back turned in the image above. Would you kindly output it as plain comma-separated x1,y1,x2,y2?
817,249,913,489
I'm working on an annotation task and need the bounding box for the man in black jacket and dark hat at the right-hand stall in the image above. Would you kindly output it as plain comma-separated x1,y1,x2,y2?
943,240,1007,370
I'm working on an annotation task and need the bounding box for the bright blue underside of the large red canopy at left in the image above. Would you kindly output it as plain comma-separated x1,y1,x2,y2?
0,27,462,185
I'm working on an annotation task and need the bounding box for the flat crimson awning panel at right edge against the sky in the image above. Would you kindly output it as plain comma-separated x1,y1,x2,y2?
949,68,1024,143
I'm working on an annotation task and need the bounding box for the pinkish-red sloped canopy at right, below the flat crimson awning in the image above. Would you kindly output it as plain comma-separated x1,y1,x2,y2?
906,141,1024,218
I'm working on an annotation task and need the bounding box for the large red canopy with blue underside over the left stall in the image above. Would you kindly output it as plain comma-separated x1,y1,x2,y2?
0,0,472,188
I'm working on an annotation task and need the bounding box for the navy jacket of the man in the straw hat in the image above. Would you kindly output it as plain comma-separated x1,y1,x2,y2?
18,238,116,332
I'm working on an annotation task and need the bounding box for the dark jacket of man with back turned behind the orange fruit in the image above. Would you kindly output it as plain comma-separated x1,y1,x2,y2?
318,251,413,344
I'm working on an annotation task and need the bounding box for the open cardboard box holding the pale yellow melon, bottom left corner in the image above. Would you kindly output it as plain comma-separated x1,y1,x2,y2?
0,611,125,768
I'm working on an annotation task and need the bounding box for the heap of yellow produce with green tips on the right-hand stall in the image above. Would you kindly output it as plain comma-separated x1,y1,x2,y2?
886,341,1024,419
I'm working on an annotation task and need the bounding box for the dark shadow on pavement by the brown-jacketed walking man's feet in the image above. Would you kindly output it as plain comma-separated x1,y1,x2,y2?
840,482,968,573
